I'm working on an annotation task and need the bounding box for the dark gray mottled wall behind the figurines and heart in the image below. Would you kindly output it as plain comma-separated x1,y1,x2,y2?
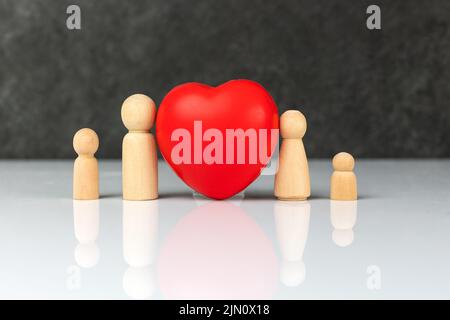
0,0,450,158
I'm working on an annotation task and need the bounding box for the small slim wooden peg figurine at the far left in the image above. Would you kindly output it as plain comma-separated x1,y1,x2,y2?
73,128,99,200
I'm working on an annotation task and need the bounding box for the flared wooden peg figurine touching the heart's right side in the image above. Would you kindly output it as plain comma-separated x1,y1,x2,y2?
274,110,311,200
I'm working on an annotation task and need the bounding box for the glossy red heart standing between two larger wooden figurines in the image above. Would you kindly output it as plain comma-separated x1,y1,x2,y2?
156,80,278,199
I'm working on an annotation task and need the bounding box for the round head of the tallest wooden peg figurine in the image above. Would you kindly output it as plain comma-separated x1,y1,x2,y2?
121,94,156,131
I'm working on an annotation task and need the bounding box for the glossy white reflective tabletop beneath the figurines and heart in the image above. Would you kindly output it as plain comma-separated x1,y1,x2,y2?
0,160,450,299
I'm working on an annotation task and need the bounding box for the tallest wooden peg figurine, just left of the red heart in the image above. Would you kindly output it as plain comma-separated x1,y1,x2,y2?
122,94,158,200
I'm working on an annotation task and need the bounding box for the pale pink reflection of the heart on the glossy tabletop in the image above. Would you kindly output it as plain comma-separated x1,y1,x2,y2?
157,201,279,299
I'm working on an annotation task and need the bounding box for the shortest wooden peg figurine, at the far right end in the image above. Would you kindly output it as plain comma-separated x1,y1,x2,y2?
330,152,358,200
